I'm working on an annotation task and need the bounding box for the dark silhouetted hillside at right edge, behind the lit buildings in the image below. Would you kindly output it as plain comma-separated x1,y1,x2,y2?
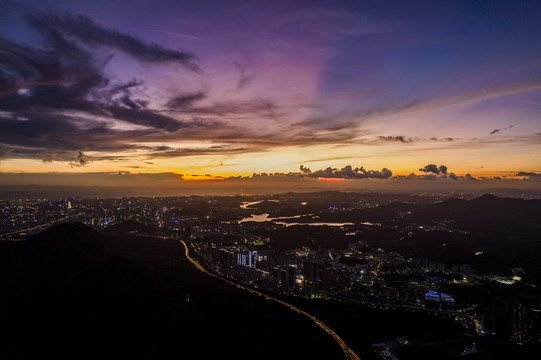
376,195,541,282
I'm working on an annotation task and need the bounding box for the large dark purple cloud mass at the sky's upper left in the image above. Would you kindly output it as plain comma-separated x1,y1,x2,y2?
0,6,208,166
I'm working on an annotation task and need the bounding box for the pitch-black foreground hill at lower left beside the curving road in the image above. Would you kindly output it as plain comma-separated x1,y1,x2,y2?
0,223,343,359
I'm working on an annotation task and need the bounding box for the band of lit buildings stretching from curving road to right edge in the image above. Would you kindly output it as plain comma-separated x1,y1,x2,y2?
195,233,541,344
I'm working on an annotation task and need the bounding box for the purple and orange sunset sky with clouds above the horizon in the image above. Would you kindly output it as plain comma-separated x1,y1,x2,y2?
0,0,541,194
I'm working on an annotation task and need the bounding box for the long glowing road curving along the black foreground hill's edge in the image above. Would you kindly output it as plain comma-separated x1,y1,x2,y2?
180,240,360,360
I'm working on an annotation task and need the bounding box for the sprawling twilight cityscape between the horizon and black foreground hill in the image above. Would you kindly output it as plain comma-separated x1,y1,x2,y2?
0,192,541,359
